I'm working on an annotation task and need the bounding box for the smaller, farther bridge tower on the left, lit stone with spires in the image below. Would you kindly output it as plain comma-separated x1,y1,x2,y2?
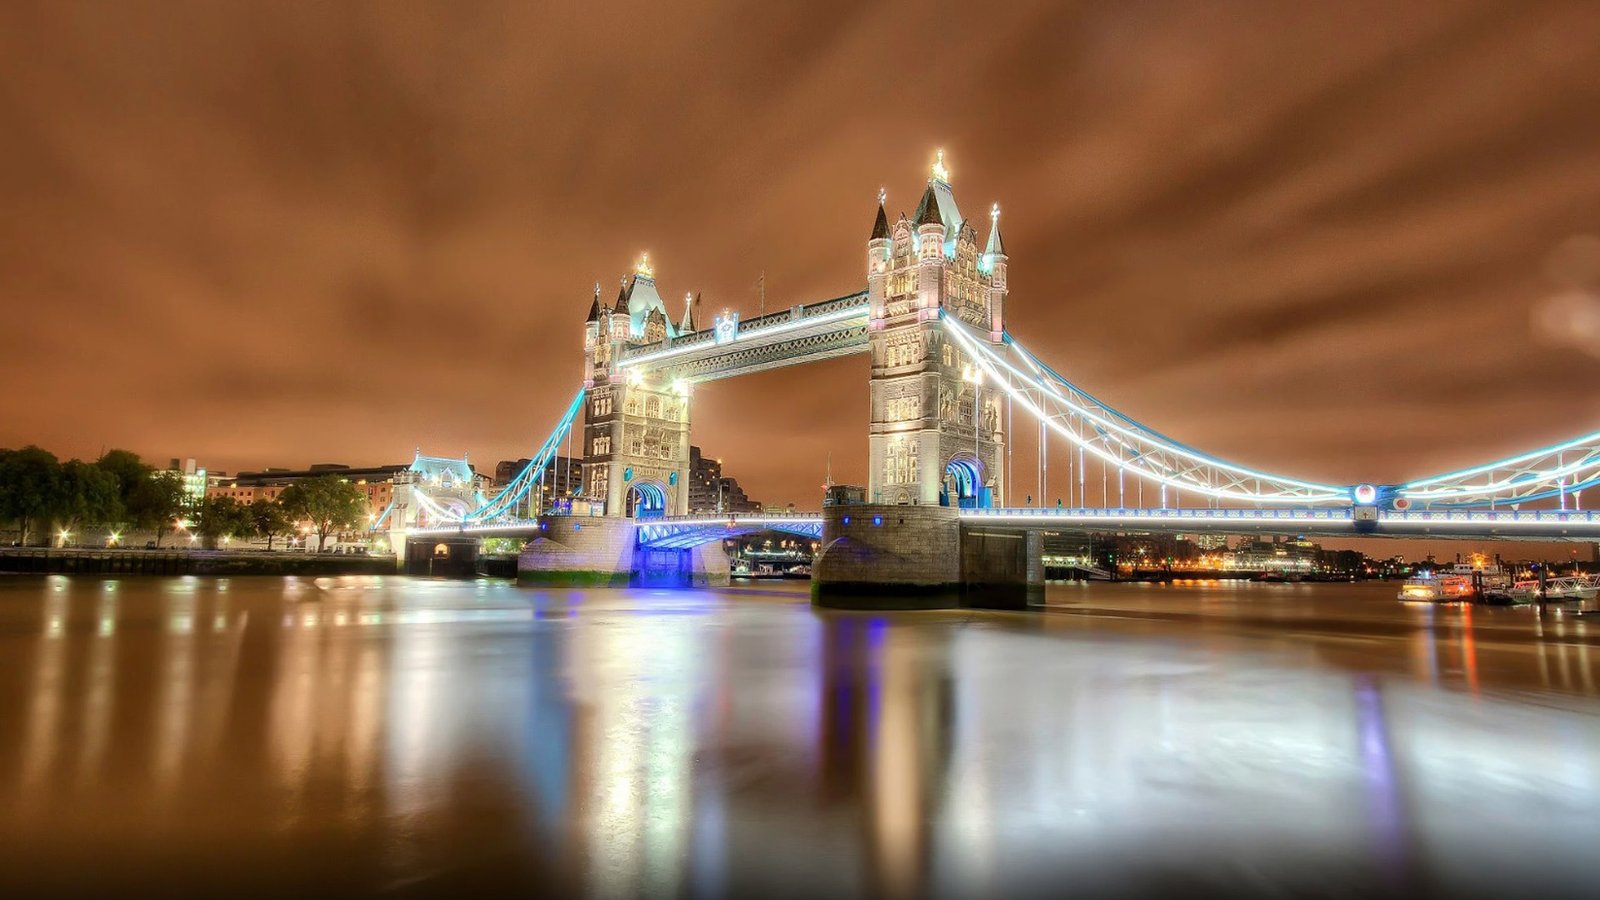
582,256,690,517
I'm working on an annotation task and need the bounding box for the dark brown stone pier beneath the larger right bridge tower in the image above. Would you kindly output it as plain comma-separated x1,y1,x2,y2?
811,504,1045,609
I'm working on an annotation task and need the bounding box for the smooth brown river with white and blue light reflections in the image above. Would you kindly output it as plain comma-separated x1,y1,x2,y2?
0,577,1600,897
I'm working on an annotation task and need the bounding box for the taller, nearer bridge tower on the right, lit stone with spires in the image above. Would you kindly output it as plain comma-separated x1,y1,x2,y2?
867,151,1006,506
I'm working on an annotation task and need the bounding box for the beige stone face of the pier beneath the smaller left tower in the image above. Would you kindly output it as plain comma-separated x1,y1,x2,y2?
517,516,637,588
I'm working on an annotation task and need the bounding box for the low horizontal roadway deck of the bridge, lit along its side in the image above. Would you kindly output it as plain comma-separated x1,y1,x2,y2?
400,506,1600,546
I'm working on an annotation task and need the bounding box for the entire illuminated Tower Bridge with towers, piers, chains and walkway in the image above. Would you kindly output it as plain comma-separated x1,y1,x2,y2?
386,154,1600,605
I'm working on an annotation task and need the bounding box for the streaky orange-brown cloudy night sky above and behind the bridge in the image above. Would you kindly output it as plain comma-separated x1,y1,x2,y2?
0,0,1600,522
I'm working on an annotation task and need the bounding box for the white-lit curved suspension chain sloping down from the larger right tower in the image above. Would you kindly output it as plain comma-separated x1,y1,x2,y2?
941,311,1350,506
